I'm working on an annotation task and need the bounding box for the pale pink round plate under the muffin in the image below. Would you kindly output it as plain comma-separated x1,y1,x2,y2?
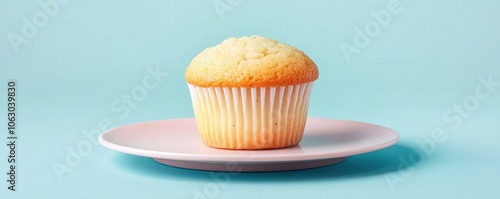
99,118,399,172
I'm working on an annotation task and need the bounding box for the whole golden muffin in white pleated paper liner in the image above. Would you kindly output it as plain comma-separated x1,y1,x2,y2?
185,36,319,149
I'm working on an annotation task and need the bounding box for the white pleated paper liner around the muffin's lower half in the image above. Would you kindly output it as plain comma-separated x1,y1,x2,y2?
188,82,313,149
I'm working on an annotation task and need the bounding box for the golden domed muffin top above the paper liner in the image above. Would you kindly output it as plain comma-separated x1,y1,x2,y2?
185,36,318,87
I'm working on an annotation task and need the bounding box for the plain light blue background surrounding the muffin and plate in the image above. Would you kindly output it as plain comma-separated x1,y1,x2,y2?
0,0,500,198
